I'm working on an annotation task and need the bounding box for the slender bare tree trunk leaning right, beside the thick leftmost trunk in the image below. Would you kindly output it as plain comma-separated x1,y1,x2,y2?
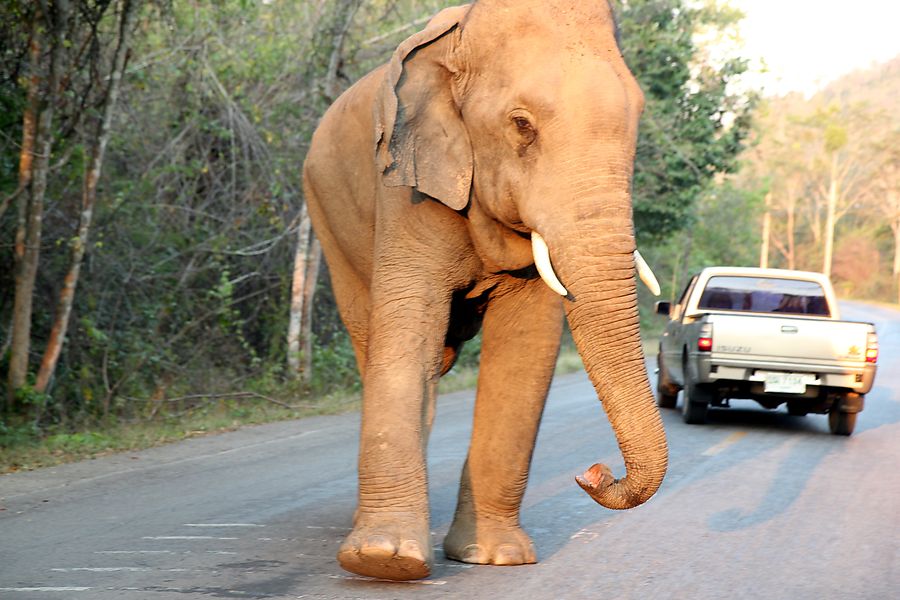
34,0,140,392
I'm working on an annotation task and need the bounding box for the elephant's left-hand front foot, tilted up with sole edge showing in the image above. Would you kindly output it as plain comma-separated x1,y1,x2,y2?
337,515,434,581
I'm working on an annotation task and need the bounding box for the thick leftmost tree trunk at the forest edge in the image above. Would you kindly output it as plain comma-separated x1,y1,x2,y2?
8,0,69,406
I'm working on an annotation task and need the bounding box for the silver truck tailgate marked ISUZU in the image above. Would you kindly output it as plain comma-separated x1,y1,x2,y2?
707,313,871,366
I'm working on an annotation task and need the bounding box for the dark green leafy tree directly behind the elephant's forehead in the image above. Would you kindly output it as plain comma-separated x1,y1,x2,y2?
616,0,756,242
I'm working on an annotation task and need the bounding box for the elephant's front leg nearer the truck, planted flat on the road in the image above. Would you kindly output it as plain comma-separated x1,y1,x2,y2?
444,280,563,565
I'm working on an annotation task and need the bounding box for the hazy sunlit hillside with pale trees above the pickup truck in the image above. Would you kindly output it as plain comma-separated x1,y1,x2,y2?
733,57,900,300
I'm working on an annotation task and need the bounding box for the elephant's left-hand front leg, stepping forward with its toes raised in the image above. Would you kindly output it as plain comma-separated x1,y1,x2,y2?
338,294,449,580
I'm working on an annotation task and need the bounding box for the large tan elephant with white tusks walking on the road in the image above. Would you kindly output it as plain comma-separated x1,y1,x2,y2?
303,0,668,580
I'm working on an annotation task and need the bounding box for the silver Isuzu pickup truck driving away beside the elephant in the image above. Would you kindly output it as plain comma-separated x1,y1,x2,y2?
656,267,878,435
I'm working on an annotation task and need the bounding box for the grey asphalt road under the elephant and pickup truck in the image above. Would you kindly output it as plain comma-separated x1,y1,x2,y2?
0,305,900,600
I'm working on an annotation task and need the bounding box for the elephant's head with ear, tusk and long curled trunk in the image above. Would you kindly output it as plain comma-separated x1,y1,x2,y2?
375,0,668,509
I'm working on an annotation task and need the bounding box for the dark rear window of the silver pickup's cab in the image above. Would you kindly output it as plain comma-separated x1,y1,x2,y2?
700,276,831,317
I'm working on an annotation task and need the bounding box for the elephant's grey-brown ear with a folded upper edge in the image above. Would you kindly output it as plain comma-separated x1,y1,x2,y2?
375,6,472,210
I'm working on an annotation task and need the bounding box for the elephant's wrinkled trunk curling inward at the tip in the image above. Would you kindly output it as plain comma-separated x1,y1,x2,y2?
536,218,668,509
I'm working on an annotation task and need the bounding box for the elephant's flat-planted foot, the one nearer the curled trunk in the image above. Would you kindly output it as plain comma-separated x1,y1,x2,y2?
444,515,537,565
